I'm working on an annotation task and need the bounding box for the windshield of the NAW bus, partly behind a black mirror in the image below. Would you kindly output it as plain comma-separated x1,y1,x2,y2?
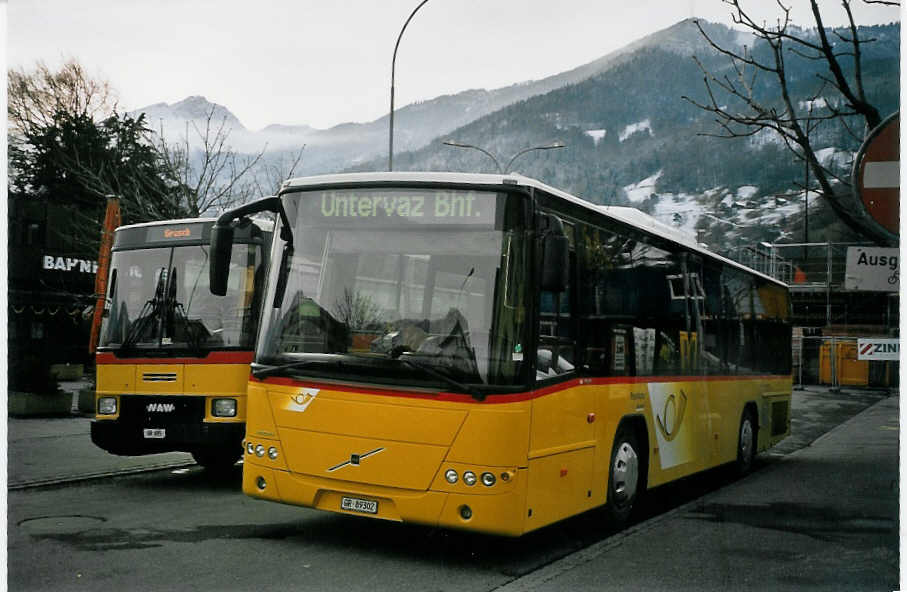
99,244,261,354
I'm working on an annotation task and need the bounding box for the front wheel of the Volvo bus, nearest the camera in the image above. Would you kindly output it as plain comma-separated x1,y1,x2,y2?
605,425,645,525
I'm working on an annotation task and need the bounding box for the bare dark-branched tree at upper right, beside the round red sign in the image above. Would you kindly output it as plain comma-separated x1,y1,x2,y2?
684,0,899,244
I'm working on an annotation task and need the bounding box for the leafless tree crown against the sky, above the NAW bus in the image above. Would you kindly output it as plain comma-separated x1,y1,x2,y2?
155,106,264,216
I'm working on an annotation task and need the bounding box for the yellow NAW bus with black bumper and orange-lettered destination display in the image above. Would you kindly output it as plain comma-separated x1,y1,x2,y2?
91,218,271,469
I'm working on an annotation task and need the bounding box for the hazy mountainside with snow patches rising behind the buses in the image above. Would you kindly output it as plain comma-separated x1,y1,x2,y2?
133,21,900,252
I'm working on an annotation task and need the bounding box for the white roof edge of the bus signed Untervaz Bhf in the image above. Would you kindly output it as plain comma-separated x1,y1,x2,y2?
281,171,787,287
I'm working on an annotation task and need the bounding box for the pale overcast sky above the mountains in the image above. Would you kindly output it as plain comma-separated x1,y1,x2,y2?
7,0,900,129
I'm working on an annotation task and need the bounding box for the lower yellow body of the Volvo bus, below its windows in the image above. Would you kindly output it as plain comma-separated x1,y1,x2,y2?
243,376,791,536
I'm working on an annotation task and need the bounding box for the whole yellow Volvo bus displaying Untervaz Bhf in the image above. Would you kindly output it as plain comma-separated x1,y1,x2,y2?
211,173,791,536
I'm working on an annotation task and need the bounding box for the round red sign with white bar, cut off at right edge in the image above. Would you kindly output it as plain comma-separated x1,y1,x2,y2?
853,113,901,237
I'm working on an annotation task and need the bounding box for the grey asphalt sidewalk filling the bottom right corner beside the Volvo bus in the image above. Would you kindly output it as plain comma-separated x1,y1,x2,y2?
498,395,899,592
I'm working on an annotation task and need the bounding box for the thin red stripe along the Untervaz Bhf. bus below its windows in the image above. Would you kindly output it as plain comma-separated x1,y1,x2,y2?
250,374,790,404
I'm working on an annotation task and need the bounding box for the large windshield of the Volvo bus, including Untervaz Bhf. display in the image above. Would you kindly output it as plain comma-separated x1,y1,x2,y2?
256,188,527,391
